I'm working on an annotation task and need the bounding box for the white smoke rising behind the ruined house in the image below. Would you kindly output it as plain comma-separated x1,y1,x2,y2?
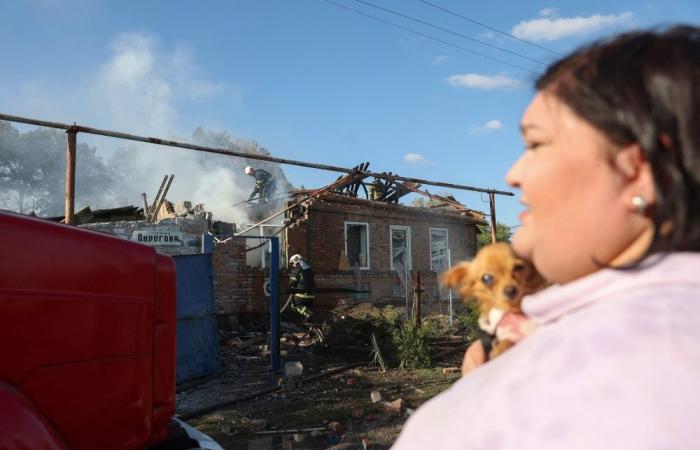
93,32,286,224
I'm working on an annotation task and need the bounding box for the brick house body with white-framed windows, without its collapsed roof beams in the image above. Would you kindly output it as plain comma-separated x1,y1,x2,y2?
214,193,484,314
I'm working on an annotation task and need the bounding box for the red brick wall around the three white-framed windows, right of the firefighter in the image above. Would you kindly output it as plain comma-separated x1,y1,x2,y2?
287,196,476,306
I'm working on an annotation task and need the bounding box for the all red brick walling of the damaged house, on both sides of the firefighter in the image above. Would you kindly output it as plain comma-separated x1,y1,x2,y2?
213,196,476,314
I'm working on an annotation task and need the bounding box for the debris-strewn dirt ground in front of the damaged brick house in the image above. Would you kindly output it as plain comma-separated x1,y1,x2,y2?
177,304,469,450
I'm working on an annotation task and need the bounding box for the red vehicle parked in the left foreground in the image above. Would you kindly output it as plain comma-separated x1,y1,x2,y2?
0,212,221,450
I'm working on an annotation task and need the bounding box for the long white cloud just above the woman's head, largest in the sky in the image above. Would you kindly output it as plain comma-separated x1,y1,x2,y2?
511,12,634,41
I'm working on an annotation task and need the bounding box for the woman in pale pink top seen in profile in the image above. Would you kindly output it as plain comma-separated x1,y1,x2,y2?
393,27,700,450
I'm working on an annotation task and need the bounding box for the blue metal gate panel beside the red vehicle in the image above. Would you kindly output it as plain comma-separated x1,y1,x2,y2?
173,253,219,382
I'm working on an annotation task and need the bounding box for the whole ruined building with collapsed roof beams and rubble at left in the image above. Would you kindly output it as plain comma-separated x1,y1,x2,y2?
46,163,485,323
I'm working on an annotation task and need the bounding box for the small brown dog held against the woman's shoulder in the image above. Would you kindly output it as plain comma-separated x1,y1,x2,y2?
442,242,546,358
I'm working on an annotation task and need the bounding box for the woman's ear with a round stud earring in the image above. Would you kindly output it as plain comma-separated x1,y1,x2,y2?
614,143,656,208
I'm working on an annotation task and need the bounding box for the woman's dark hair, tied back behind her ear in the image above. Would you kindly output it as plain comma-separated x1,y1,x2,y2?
536,26,700,254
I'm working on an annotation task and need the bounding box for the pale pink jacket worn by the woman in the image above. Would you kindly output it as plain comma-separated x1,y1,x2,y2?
392,253,700,450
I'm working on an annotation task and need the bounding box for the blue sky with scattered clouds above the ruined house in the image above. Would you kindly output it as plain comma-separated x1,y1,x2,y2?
0,0,700,227
